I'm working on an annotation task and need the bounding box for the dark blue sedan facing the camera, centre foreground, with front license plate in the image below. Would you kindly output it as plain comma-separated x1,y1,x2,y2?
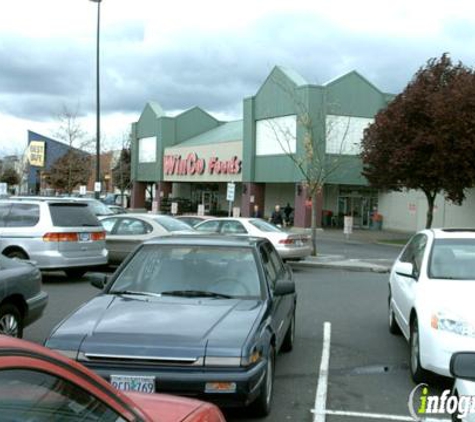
46,235,297,415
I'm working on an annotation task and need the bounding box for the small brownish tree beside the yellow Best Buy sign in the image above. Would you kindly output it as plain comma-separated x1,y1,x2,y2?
46,149,91,194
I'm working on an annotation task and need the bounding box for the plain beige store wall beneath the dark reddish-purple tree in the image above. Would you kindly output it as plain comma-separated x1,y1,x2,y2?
378,189,475,232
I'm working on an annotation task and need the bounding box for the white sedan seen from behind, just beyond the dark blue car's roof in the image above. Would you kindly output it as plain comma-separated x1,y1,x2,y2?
195,218,312,260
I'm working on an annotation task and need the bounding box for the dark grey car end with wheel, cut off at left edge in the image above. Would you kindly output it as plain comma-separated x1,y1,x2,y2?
0,255,48,338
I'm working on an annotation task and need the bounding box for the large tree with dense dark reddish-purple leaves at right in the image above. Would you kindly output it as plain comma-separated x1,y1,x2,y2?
362,54,475,228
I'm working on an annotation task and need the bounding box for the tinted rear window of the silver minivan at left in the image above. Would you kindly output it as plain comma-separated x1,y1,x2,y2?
49,203,101,227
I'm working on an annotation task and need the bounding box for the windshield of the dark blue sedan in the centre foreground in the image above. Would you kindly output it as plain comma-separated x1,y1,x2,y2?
109,245,262,298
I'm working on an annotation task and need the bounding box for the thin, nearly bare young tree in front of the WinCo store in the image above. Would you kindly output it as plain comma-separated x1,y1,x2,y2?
267,76,354,256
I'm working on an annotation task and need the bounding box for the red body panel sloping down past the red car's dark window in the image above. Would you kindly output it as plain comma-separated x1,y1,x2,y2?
124,392,224,422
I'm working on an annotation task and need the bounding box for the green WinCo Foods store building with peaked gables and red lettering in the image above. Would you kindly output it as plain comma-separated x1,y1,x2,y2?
132,67,393,228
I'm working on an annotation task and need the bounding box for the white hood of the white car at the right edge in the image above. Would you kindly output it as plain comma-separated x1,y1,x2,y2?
418,280,475,325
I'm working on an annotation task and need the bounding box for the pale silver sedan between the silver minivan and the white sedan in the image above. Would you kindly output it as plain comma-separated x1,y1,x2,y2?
101,213,194,264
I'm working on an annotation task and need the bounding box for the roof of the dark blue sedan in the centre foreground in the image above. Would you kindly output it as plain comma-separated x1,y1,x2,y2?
144,233,267,247
